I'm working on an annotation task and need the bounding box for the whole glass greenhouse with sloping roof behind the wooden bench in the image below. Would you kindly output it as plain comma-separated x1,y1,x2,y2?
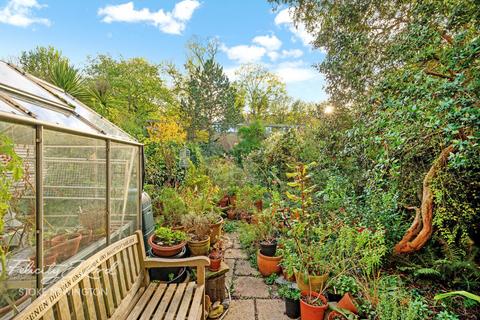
0,62,143,318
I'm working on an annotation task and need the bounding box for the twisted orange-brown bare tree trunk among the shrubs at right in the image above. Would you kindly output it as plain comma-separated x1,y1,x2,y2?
394,145,454,254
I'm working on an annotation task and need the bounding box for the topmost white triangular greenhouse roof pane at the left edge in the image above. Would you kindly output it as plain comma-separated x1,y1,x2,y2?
0,61,62,103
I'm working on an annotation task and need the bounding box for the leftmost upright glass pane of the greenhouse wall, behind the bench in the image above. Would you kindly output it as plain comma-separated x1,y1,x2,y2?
0,122,36,319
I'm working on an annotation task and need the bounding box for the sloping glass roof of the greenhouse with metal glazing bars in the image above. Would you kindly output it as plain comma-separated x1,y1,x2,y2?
0,61,135,143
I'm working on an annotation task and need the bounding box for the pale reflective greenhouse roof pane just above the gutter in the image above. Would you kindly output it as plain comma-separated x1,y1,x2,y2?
12,98,100,134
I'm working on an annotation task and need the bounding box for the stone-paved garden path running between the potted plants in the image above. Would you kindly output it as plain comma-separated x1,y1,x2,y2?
219,232,289,320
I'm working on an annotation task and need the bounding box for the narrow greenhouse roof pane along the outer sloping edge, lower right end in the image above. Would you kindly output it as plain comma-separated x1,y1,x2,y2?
39,86,132,140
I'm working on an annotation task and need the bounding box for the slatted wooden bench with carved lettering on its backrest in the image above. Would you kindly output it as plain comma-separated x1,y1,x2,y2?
15,231,210,320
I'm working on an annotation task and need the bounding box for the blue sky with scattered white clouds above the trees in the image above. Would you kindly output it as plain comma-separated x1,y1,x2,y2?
0,0,328,101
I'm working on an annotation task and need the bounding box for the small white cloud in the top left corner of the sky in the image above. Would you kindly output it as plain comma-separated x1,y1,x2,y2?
0,0,51,27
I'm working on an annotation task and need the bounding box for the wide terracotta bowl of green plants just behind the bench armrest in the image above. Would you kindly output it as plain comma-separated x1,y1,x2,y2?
148,224,187,257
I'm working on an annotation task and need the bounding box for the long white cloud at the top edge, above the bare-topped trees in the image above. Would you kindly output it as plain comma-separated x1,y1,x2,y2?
98,0,200,34
